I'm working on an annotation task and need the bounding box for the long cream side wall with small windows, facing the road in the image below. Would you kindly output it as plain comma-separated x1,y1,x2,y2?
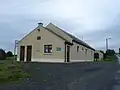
70,42,94,62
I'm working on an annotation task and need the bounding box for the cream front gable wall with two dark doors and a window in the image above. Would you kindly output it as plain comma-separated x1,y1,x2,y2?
18,27,65,62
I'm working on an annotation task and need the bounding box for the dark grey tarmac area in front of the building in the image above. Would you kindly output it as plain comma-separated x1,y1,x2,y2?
0,62,118,90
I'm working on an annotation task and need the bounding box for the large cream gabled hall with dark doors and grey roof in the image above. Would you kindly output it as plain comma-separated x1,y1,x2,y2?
17,23,95,62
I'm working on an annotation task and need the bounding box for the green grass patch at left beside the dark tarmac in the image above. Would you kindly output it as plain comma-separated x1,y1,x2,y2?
0,60,30,83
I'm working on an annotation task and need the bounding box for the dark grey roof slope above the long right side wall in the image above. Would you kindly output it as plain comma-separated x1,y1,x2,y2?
63,31,95,51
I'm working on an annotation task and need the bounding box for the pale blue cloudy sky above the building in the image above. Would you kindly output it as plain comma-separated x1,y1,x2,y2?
0,0,120,51
